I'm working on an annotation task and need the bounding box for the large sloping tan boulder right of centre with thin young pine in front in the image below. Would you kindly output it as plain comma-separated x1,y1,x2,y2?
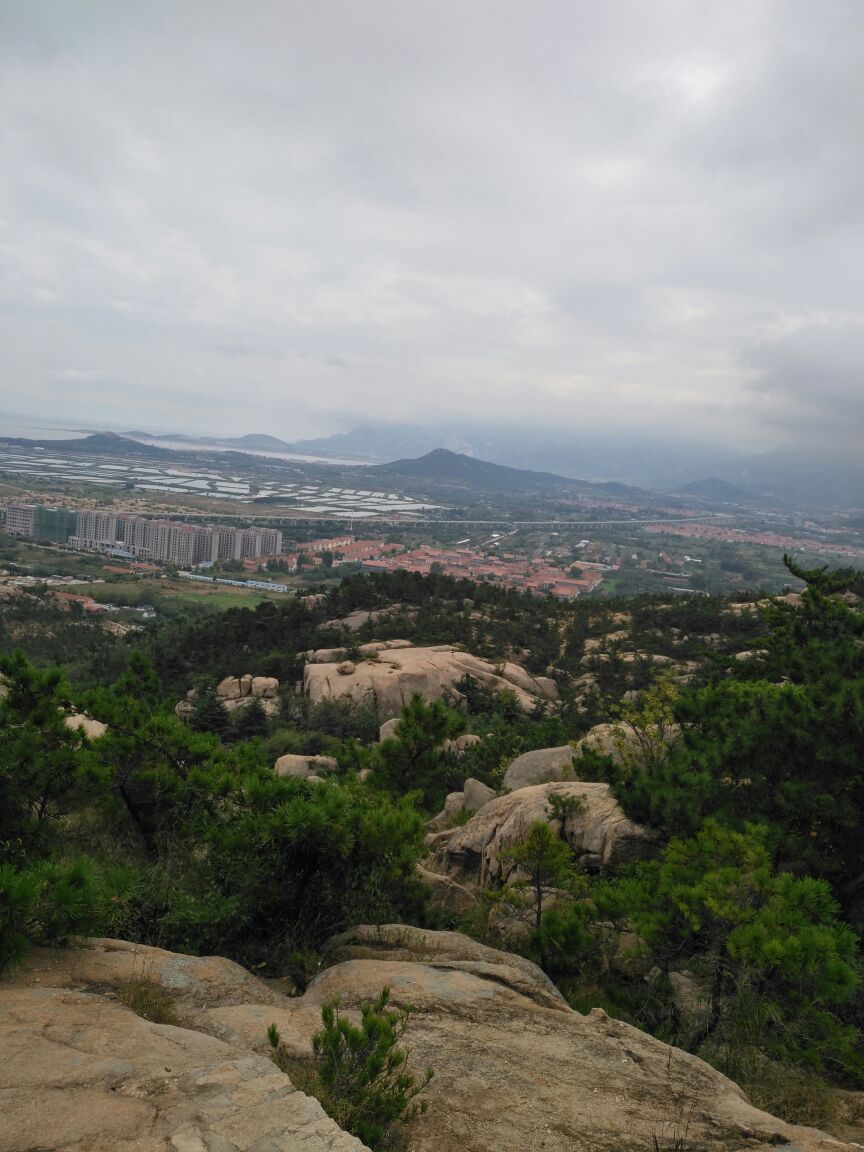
426,781,657,888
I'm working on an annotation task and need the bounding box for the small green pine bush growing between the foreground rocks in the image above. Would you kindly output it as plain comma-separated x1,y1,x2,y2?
267,987,433,1152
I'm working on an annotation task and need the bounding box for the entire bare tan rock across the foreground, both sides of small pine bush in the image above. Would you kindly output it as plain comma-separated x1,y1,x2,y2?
0,925,852,1152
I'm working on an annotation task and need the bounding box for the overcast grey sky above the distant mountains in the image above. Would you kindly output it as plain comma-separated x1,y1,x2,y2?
0,0,864,447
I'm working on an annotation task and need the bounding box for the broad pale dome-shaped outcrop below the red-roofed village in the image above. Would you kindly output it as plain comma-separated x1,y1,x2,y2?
303,641,558,719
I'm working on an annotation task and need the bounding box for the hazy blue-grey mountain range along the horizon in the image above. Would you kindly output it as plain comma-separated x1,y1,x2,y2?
13,424,864,509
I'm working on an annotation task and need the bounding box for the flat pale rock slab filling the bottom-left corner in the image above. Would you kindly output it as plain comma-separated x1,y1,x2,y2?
0,984,364,1152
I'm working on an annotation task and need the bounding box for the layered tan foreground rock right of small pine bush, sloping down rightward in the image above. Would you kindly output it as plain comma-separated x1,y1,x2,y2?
206,925,851,1152
